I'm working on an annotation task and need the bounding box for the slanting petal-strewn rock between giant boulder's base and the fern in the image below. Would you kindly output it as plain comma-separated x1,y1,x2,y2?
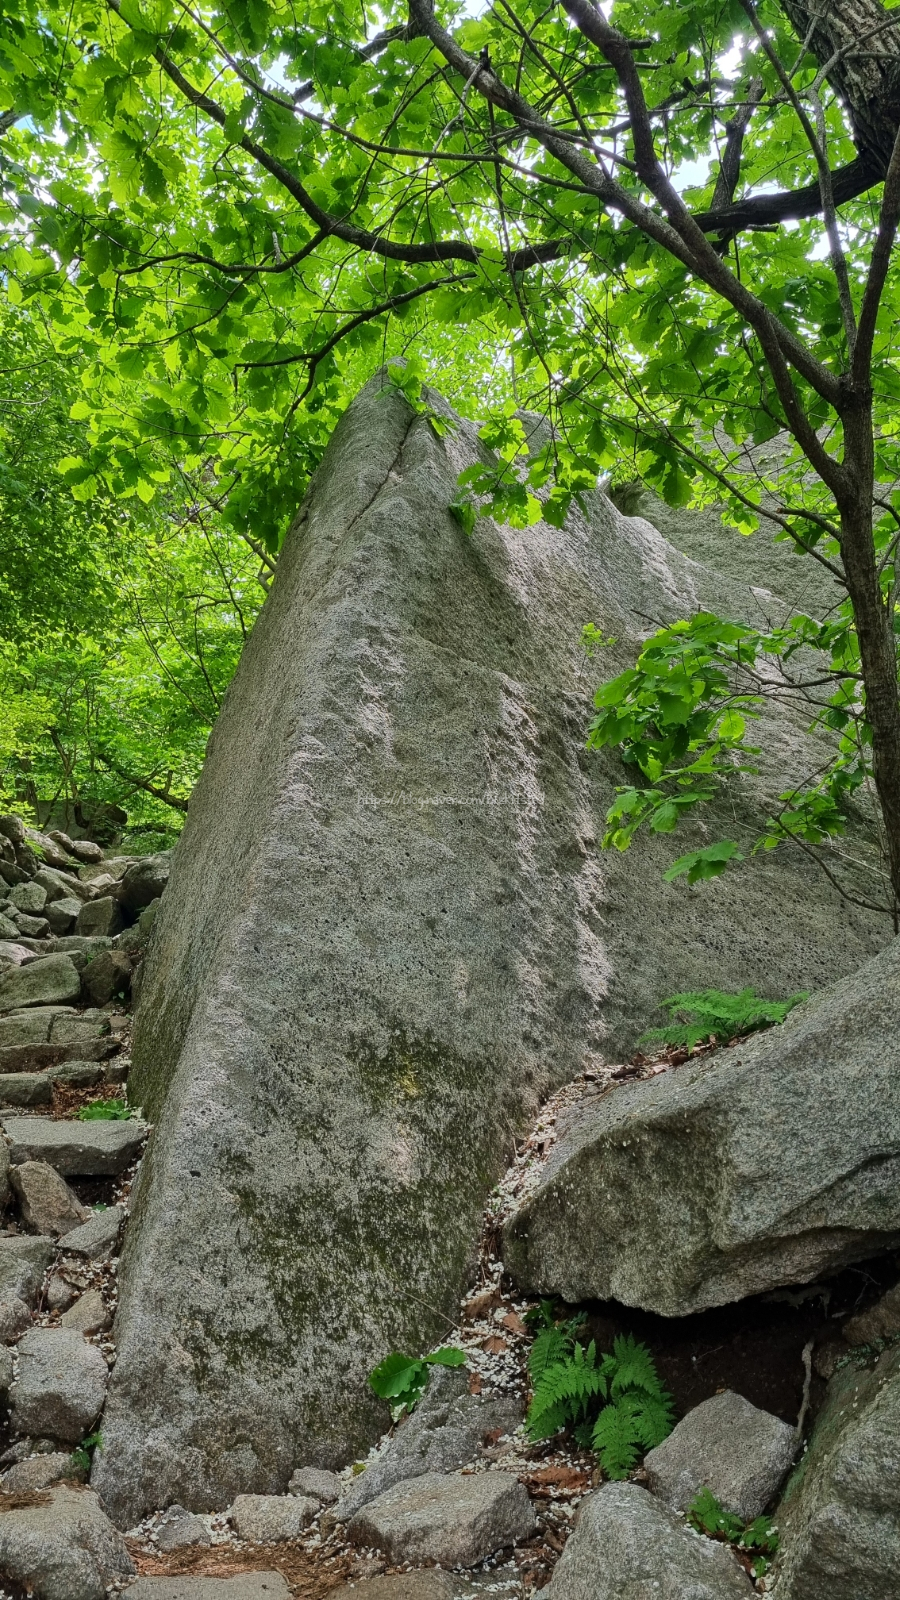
331,1366,524,1522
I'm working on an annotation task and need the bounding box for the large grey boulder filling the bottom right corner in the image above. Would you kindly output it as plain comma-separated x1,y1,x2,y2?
773,1347,900,1600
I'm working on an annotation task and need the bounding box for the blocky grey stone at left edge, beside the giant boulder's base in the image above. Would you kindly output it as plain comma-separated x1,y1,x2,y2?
10,1328,107,1445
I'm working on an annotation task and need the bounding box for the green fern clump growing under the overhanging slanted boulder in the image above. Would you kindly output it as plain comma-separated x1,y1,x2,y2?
525,1302,674,1478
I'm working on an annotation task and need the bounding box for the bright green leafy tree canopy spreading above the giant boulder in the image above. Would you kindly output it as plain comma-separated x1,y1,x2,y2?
0,0,900,904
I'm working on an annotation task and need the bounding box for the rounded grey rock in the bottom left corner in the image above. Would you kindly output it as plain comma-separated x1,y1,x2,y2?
0,1478,132,1600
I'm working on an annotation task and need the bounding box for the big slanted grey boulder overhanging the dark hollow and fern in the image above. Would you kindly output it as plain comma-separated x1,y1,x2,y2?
503,941,900,1317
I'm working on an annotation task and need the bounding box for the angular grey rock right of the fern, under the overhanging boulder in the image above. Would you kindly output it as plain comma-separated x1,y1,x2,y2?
644,1389,796,1522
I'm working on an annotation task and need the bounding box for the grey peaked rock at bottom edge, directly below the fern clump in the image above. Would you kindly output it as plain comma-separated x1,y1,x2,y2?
544,1483,749,1600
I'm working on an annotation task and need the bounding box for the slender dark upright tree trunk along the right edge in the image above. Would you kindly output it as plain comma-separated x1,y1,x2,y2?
839,402,900,920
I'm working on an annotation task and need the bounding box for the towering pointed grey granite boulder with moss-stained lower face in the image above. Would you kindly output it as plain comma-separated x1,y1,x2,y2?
94,382,886,1522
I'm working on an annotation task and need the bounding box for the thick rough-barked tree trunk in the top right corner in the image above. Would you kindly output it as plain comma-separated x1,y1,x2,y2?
778,0,900,176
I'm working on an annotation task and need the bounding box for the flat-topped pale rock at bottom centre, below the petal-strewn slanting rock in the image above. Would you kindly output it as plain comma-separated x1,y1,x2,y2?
348,1472,535,1566
